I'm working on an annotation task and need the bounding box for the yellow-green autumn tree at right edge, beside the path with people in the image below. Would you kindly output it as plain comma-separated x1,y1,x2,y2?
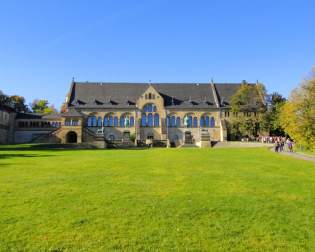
280,70,315,149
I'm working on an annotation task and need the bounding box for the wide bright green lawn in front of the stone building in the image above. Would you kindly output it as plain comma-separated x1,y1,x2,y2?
0,148,315,251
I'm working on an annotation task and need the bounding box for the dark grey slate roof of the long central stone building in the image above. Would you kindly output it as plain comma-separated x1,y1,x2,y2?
68,82,258,108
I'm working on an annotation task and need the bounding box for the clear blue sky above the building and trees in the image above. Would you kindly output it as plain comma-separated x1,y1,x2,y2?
0,0,315,108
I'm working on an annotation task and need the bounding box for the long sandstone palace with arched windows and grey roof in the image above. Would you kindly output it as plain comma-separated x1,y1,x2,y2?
2,81,264,148
